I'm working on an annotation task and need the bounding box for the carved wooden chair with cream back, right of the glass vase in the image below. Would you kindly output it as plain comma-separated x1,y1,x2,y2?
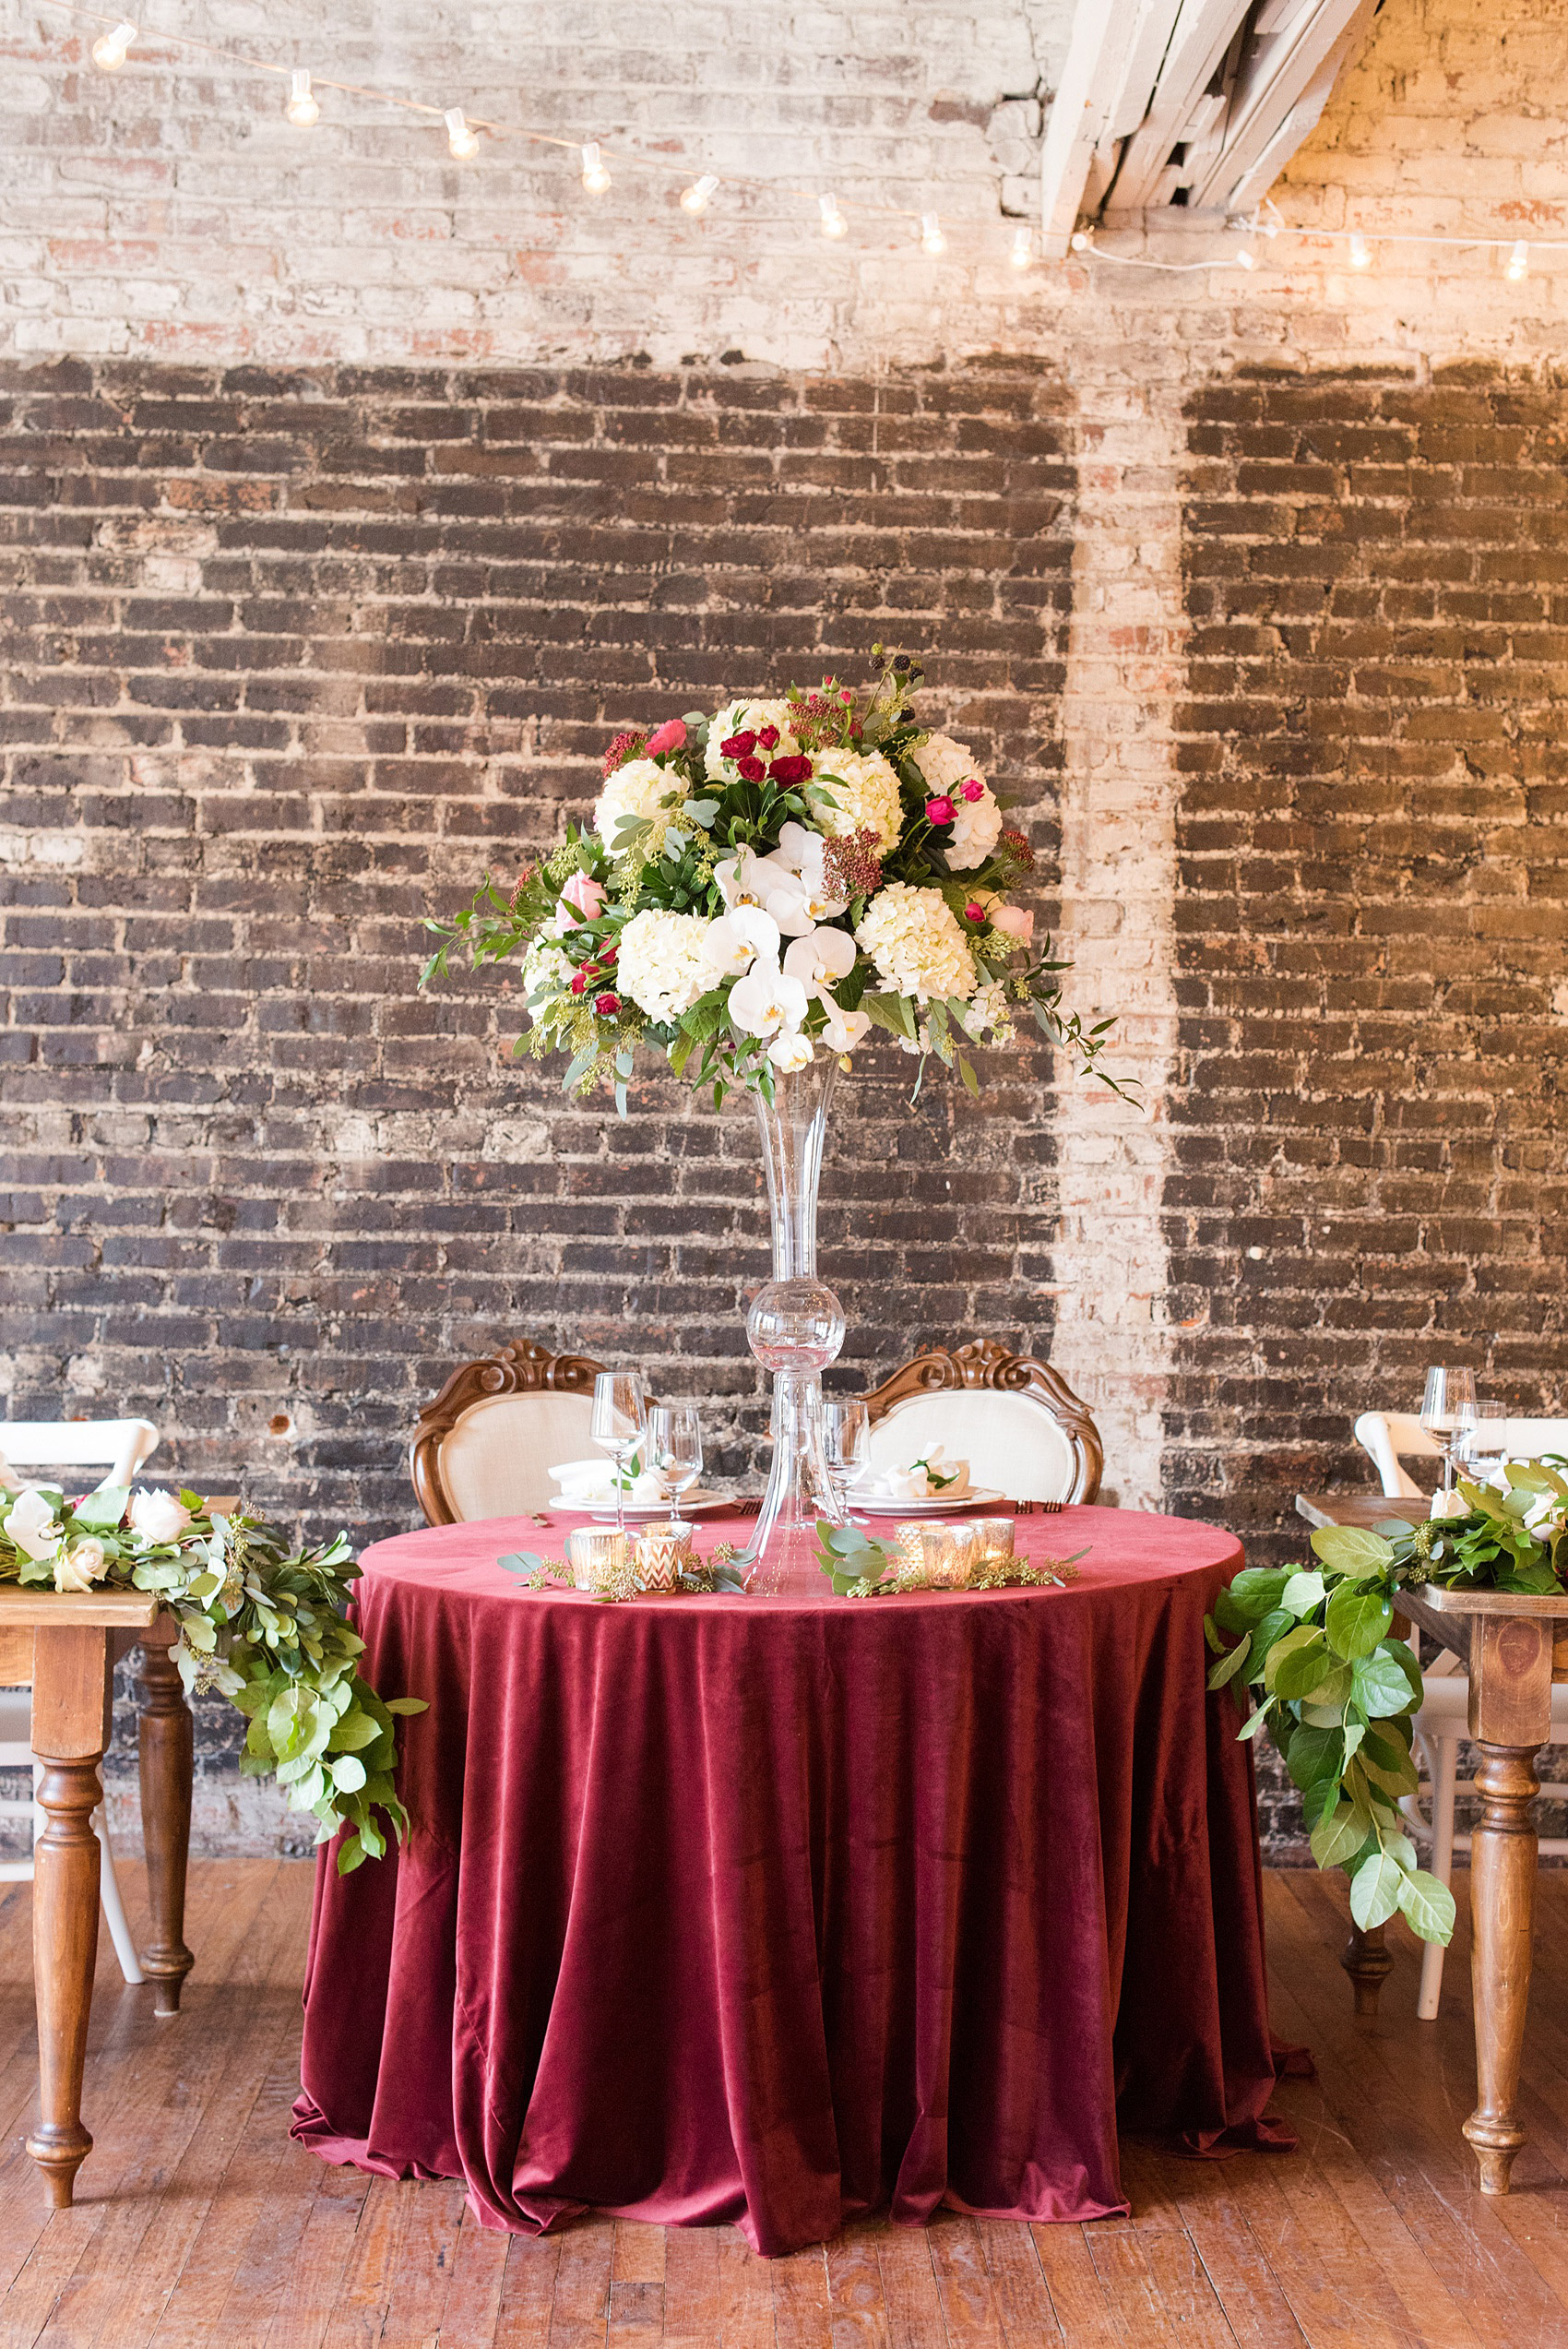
866,1337,1106,1501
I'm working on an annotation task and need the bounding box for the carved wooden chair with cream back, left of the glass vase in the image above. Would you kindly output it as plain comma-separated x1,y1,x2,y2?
409,1337,603,1524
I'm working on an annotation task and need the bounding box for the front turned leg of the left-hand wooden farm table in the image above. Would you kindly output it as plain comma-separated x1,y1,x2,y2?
29,1626,108,2211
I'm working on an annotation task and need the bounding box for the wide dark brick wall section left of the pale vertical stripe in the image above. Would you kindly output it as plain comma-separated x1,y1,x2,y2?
0,347,1070,1536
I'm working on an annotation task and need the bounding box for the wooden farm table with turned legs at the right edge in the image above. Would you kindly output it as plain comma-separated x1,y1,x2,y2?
1296,1494,1568,2194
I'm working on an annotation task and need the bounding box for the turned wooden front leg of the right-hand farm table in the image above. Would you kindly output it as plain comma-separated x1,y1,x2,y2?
1465,1746,1539,2194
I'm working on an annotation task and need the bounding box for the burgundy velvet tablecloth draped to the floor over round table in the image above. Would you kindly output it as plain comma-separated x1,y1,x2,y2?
293,1508,1289,2253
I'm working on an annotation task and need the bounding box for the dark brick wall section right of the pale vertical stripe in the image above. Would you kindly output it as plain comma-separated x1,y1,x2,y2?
1164,364,1568,1851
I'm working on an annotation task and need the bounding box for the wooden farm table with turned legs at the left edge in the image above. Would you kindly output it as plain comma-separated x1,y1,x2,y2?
0,1591,193,2211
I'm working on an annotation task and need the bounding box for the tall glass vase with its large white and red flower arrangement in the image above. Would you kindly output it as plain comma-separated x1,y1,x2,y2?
425,646,1120,1588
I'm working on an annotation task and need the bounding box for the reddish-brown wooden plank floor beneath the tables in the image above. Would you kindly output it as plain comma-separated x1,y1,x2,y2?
0,1860,1568,2349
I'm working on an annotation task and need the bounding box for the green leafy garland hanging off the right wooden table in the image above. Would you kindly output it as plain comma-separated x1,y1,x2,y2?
1205,1461,1568,1943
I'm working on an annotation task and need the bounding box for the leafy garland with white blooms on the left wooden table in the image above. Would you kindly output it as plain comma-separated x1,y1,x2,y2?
0,1485,425,1875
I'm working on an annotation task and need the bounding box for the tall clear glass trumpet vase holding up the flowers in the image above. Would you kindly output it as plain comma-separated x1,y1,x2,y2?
737,1053,845,1597
